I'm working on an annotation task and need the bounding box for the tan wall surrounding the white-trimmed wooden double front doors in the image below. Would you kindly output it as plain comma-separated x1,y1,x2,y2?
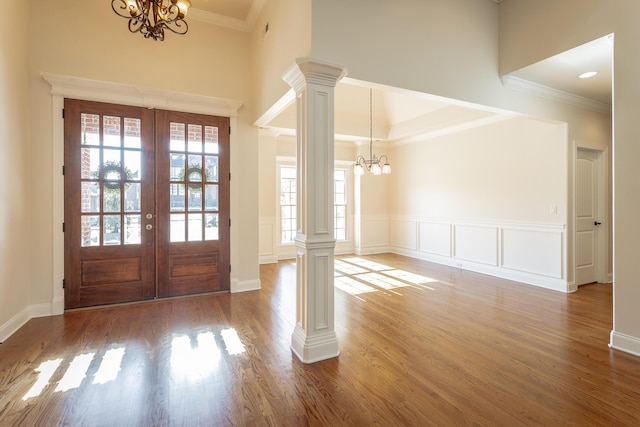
29,0,258,304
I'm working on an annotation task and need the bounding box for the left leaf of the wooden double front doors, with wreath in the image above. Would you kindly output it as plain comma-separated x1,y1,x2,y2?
64,99,155,308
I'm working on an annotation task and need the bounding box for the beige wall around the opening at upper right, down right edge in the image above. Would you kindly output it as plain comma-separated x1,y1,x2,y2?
500,0,640,354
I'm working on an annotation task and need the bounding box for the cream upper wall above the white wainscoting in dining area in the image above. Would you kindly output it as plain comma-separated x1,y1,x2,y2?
391,118,567,224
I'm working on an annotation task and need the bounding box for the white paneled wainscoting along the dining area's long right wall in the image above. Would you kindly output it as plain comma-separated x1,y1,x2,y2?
389,217,575,292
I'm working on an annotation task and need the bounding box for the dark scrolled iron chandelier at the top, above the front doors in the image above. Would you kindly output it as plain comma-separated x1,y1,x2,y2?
111,0,191,41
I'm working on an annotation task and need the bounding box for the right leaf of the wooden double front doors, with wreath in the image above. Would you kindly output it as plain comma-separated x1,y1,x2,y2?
156,111,230,297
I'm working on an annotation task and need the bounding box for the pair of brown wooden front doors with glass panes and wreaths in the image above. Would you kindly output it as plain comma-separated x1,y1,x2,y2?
64,99,230,308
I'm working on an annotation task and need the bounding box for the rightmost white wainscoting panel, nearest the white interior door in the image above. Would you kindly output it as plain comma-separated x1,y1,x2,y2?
502,227,562,279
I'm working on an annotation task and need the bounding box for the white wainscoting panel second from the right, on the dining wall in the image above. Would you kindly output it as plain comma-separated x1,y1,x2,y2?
453,224,498,265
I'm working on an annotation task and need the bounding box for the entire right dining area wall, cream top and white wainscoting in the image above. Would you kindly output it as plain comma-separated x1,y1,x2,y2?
390,118,573,292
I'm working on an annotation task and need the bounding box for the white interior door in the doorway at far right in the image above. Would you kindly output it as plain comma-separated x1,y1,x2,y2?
576,149,603,286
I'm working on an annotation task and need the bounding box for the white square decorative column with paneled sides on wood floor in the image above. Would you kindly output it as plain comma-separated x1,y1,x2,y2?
283,58,346,363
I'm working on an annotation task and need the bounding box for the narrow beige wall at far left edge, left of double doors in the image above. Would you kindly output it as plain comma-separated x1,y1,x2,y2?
0,2,30,342
